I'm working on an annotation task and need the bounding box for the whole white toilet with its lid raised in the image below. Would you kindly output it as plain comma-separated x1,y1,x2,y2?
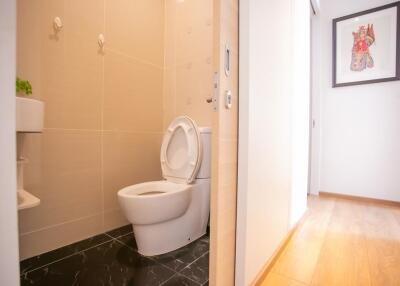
118,116,211,256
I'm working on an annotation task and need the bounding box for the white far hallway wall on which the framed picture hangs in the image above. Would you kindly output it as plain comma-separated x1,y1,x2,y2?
313,0,400,201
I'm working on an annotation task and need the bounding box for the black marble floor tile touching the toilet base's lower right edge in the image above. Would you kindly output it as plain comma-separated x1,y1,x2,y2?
151,238,209,271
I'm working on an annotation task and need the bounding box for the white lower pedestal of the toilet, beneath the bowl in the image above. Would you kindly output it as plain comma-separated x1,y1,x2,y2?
132,179,210,256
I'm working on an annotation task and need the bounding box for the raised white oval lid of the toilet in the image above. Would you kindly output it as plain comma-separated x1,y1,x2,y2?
160,116,202,183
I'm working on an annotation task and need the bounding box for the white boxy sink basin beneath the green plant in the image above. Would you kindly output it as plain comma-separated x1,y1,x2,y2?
16,96,44,132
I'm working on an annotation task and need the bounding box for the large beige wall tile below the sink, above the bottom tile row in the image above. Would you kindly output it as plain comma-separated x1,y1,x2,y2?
19,130,102,233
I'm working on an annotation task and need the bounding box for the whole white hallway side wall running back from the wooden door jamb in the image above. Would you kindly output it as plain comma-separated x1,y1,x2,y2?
236,0,309,286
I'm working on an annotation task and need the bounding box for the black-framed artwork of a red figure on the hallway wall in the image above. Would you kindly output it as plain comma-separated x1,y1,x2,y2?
333,2,400,87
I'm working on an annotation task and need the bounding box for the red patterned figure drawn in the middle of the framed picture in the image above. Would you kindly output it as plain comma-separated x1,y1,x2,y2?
350,24,375,72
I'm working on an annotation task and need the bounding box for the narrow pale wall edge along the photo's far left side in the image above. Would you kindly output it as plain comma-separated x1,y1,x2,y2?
0,0,19,286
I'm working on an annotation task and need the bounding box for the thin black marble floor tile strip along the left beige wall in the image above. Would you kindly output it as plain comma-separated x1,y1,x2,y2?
20,234,111,274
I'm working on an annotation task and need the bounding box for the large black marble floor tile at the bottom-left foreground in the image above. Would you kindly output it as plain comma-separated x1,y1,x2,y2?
21,240,173,286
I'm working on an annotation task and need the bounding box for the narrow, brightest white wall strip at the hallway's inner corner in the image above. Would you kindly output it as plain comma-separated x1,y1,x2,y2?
290,0,311,227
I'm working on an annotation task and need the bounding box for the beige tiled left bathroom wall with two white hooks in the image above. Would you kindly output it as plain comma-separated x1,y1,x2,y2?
17,0,165,259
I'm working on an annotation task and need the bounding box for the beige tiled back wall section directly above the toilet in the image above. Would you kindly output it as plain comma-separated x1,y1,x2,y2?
164,0,213,127
